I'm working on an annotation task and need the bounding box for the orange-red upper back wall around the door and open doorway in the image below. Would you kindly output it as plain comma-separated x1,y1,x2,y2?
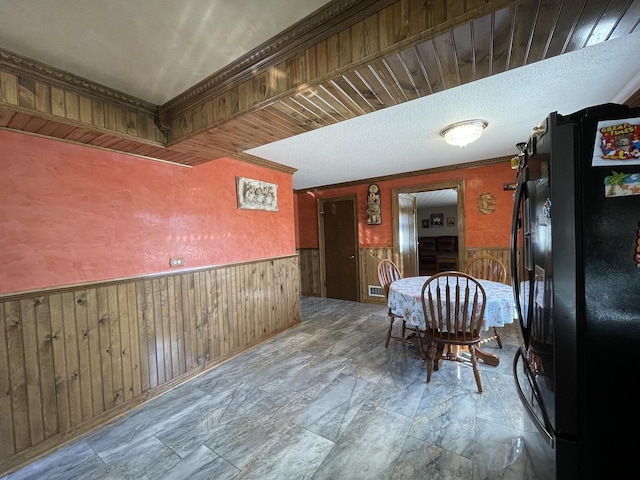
296,161,515,248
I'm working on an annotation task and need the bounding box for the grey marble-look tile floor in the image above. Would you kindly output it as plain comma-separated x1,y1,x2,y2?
2,297,544,480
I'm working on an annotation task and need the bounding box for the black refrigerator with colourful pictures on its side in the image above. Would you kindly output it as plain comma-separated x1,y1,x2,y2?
511,104,640,480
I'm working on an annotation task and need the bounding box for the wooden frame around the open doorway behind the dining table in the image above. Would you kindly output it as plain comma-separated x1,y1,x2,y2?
391,180,467,271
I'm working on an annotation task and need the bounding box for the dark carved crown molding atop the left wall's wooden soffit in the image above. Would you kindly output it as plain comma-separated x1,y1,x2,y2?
0,48,158,116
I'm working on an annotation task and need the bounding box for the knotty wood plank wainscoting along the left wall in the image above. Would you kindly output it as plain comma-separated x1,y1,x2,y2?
0,256,300,475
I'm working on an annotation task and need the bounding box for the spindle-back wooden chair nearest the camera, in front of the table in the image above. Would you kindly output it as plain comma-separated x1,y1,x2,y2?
418,272,486,393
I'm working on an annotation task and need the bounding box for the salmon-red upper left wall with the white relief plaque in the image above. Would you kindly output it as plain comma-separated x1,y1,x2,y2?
0,131,296,294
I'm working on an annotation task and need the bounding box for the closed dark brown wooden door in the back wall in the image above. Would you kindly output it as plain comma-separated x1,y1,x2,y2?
319,197,360,302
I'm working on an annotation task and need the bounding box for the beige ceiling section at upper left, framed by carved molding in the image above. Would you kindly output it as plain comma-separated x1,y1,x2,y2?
0,0,327,104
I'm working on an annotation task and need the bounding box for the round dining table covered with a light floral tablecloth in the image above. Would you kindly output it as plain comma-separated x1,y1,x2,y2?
387,276,515,366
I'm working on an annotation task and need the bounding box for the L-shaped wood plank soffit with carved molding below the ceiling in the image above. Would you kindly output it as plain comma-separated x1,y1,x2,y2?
0,0,640,171
